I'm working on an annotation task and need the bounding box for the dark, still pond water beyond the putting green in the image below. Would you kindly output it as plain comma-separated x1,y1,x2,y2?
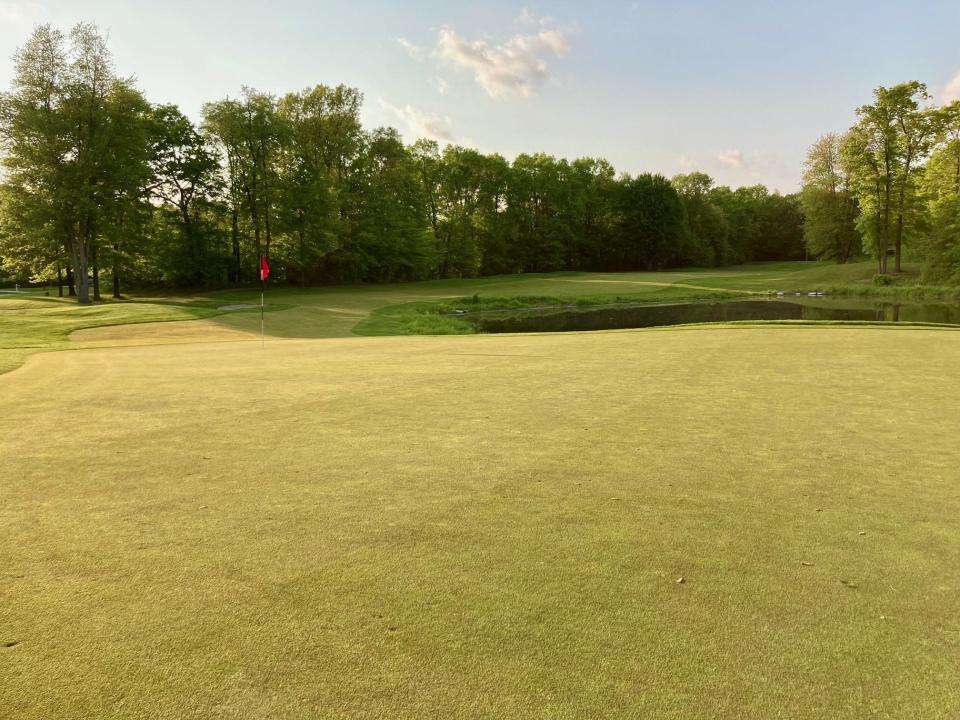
472,298,960,333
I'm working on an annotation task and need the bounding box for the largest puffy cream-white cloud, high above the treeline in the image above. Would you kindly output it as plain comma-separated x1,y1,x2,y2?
434,28,570,98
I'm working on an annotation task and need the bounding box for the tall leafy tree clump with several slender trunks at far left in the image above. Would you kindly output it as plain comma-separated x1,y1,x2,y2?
2,23,149,304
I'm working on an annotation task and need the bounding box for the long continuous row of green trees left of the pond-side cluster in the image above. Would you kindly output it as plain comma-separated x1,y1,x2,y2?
0,24,804,302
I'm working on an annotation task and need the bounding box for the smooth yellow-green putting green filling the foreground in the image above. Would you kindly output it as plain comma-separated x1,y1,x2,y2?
0,328,960,719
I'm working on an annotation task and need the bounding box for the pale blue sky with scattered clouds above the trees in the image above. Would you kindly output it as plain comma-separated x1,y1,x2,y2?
0,0,960,192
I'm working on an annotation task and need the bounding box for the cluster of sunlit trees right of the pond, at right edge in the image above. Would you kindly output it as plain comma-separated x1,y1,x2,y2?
801,81,960,284
